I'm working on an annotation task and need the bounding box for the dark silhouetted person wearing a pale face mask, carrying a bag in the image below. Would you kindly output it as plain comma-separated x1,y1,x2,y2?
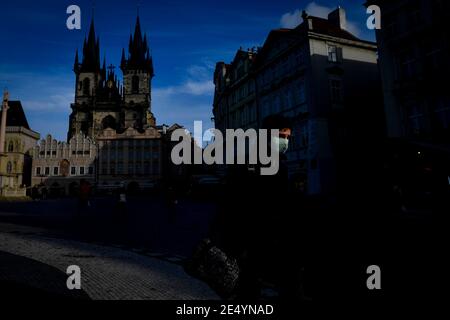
213,116,305,302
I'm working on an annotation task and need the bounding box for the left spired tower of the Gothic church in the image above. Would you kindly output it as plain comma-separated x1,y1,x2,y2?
68,19,106,140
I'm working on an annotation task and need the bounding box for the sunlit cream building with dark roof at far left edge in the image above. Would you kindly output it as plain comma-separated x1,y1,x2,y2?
0,93,40,197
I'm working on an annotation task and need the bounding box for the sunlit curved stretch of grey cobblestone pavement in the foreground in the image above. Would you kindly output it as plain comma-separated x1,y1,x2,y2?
0,225,219,300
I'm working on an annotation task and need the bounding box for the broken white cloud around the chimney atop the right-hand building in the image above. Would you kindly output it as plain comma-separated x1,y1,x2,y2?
280,1,361,37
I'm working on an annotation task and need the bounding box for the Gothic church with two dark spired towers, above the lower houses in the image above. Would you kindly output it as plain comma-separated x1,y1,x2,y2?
67,16,156,141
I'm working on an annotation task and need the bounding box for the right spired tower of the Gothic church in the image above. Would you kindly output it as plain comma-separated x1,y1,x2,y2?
120,15,155,128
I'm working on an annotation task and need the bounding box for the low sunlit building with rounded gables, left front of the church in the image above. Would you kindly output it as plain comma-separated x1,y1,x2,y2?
30,133,97,196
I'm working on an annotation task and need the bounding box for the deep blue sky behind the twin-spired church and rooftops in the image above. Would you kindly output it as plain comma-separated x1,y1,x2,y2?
0,0,374,140
